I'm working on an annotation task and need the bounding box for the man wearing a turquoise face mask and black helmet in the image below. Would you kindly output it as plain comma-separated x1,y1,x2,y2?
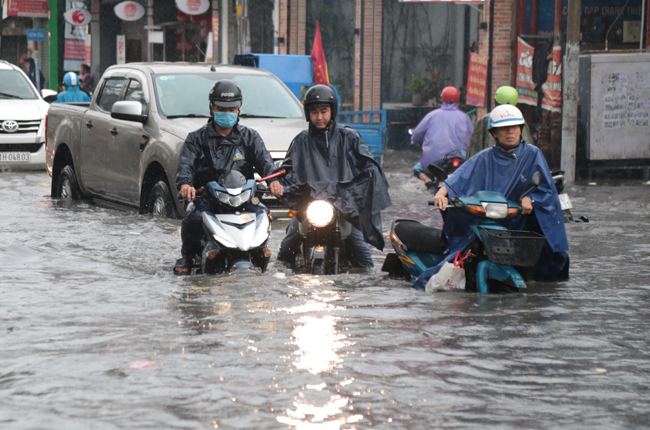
174,79,283,275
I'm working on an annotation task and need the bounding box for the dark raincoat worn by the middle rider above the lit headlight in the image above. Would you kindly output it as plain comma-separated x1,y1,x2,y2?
283,121,391,249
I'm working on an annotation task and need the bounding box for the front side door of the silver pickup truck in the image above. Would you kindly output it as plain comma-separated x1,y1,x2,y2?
107,79,147,206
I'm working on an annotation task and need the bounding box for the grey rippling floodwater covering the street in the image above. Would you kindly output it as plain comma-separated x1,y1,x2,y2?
0,152,650,430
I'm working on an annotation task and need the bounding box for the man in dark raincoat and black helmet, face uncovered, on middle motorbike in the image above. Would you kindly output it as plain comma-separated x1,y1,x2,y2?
278,85,390,267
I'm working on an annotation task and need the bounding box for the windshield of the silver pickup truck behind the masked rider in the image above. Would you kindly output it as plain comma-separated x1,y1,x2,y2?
154,73,303,118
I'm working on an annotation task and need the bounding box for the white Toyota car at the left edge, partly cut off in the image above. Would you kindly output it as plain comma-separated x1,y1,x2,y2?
0,60,56,170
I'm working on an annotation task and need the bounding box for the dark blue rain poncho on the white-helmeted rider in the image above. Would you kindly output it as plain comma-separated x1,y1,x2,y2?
413,141,569,289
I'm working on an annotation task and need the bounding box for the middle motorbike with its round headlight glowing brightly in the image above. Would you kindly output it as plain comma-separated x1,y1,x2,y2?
289,191,352,275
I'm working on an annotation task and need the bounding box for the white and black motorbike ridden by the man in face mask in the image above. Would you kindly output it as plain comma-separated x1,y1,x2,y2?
180,168,288,274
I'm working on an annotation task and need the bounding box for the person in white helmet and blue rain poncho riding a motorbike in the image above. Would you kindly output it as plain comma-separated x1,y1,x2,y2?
413,105,569,288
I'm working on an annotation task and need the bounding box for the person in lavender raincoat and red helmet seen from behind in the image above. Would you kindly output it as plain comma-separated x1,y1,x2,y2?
411,87,474,189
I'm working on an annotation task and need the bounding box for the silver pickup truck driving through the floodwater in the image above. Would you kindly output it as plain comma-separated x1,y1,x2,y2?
45,63,307,218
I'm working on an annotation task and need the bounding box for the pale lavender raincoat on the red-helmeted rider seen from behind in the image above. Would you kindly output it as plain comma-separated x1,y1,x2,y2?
412,103,474,169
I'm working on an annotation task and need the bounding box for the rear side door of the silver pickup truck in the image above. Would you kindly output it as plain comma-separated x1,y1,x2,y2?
81,77,126,198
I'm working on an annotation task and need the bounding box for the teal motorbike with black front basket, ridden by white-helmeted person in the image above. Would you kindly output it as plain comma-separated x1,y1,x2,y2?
382,166,546,293
